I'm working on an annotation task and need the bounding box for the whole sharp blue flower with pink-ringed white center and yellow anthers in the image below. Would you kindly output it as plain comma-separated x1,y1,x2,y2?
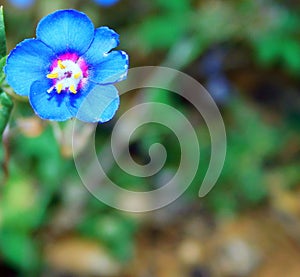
4,10,128,122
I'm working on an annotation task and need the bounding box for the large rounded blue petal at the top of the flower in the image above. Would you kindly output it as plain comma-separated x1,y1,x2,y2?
36,10,94,55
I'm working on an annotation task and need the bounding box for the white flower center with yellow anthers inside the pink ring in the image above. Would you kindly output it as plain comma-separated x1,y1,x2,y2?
47,60,84,94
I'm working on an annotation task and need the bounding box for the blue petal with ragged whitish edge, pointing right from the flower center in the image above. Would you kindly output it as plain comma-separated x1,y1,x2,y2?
90,51,129,85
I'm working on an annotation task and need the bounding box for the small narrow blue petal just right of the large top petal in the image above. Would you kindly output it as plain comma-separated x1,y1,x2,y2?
83,27,119,64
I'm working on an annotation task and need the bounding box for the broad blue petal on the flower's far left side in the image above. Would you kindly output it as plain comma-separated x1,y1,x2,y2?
4,39,55,96
